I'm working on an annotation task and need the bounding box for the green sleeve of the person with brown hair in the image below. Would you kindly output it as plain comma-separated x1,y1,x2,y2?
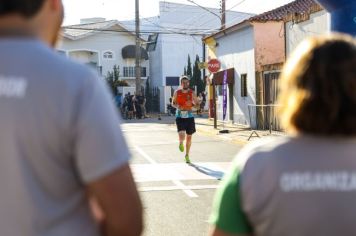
210,162,253,234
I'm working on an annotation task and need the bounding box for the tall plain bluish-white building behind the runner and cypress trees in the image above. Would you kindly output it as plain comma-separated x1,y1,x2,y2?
122,1,252,112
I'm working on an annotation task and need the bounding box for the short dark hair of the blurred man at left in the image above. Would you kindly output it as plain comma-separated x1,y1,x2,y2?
0,0,45,18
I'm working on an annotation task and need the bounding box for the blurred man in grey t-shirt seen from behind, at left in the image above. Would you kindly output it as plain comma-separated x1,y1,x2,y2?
0,0,142,236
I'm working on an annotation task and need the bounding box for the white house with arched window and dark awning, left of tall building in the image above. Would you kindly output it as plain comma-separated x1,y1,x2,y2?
57,18,149,86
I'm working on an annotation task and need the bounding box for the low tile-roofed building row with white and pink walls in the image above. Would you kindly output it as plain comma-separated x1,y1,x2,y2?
204,0,330,130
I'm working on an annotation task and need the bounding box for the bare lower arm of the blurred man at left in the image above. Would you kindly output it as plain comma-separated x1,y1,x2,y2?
87,165,143,236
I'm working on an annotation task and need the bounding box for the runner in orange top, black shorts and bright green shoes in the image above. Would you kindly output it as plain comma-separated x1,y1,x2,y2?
172,75,200,163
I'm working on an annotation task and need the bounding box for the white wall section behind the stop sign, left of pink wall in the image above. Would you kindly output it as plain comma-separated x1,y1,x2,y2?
203,21,256,125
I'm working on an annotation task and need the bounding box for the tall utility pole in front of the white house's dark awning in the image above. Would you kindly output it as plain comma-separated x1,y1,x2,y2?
135,0,141,95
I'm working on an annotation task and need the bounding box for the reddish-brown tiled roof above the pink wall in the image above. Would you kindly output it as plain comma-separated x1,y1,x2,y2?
250,0,322,21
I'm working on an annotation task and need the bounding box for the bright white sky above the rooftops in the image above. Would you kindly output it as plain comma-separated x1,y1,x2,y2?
62,0,293,25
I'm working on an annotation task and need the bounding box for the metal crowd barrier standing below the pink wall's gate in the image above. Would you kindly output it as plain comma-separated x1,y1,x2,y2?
248,104,283,134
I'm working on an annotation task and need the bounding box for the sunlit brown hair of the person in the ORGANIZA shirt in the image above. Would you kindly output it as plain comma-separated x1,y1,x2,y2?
280,35,356,136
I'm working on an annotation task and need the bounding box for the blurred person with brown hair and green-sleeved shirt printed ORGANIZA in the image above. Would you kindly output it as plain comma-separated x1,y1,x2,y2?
211,35,356,236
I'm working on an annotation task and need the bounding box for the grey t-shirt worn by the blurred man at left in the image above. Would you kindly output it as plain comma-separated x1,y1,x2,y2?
0,39,130,236
